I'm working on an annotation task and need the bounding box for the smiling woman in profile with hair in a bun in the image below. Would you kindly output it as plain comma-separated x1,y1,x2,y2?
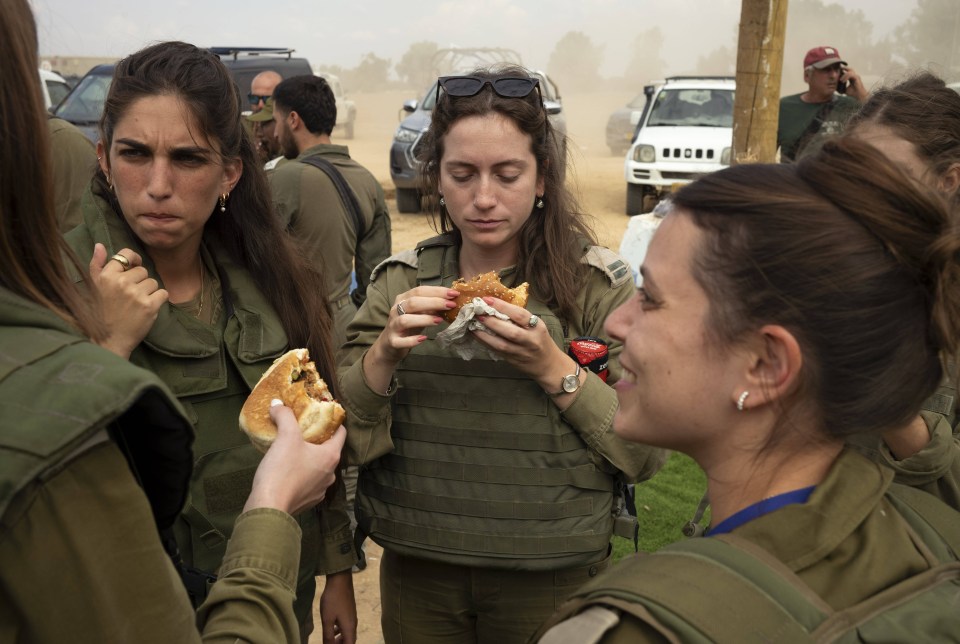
540,140,960,642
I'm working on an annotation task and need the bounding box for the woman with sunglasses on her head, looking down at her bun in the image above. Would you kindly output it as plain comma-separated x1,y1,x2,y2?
341,67,663,644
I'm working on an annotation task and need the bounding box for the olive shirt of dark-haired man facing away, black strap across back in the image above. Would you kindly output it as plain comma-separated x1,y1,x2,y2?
268,144,392,346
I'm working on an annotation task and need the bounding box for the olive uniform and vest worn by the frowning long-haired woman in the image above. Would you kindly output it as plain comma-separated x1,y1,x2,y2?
67,184,356,624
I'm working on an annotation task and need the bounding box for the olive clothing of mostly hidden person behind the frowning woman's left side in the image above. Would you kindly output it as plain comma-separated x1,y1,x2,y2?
47,116,97,233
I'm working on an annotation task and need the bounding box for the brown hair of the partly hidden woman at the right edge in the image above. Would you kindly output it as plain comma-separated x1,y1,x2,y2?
844,71,960,208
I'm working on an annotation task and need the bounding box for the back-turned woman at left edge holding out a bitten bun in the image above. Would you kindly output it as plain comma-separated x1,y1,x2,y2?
0,0,345,643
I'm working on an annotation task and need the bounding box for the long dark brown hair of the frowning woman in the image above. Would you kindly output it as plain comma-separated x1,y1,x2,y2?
94,42,336,388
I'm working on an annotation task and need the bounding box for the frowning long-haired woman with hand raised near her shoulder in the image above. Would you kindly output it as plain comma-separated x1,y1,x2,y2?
62,42,356,641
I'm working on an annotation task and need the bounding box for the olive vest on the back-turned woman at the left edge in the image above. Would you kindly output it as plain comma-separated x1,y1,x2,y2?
0,314,193,538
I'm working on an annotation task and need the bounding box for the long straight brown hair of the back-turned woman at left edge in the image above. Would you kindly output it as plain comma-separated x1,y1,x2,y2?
0,0,103,340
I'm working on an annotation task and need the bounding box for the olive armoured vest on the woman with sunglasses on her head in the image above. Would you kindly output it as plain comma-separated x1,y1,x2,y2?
357,237,616,570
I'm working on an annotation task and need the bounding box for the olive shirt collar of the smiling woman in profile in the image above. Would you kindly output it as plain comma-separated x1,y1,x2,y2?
733,448,893,571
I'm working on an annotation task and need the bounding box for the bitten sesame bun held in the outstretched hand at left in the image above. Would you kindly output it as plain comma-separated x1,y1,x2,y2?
240,349,346,453
